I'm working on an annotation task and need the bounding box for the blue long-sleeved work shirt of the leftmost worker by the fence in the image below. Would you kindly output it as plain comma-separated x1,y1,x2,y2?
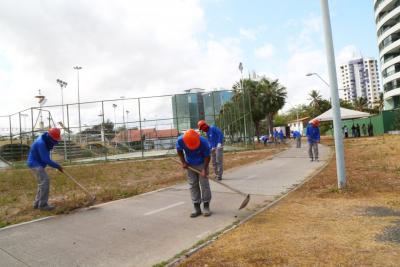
27,132,60,169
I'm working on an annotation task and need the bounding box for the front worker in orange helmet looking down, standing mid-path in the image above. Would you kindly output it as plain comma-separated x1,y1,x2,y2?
176,129,211,218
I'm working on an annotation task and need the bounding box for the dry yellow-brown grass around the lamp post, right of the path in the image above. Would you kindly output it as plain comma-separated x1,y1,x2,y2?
181,136,400,266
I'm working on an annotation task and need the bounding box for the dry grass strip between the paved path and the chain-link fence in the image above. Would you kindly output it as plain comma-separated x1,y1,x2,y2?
0,146,284,227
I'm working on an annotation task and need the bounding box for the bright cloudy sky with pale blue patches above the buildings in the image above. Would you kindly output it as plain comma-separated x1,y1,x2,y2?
0,0,378,129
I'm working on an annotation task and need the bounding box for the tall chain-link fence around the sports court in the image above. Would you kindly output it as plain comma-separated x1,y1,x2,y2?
0,89,254,163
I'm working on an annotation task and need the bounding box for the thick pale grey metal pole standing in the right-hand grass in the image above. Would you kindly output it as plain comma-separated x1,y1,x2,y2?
320,0,346,189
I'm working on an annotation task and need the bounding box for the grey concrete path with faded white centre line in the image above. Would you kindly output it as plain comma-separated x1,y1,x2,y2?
0,143,329,267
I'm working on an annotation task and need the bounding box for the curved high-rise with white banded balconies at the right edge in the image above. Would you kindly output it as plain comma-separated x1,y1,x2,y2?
374,0,400,110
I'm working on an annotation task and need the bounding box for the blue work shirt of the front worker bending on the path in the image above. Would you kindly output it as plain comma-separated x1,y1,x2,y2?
176,136,211,166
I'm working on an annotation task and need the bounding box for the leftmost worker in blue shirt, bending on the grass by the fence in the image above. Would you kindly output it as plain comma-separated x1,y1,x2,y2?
27,128,63,211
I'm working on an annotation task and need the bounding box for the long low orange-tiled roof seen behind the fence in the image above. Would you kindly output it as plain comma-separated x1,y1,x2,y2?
113,128,179,142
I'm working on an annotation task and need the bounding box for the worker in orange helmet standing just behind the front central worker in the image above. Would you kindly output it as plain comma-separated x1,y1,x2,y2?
197,120,224,180
